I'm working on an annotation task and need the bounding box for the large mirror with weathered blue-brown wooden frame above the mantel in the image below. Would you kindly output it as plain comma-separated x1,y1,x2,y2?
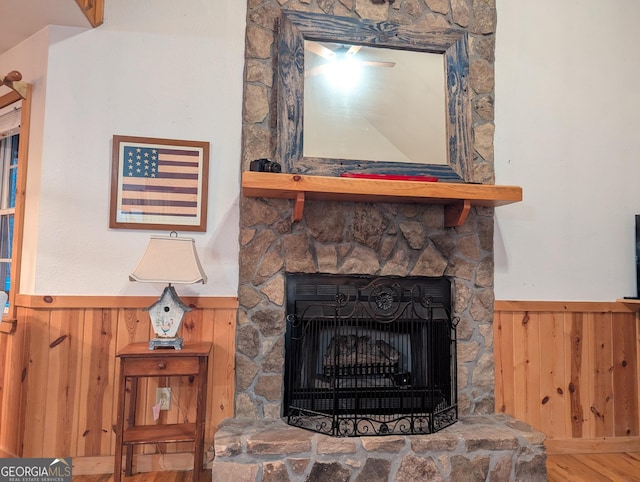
277,10,473,182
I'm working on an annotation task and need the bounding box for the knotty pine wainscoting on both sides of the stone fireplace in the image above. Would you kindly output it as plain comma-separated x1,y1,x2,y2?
0,296,640,464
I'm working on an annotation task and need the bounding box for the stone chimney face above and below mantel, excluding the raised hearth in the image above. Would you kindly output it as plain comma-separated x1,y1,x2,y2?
236,0,496,419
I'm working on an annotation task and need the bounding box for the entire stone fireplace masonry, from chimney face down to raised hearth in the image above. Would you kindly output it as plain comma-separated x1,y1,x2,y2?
213,0,546,481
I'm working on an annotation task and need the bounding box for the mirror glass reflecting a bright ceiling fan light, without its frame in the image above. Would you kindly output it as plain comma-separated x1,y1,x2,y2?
303,40,448,165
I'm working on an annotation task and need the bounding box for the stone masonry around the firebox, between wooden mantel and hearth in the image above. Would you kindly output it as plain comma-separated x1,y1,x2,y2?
236,198,494,419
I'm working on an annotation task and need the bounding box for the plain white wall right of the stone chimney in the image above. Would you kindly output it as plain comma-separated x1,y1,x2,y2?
495,0,640,301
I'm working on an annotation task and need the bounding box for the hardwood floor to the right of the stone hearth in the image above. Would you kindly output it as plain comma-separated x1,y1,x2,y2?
547,452,640,482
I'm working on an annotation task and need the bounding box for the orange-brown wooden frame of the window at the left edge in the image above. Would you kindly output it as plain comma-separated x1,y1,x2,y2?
0,82,31,320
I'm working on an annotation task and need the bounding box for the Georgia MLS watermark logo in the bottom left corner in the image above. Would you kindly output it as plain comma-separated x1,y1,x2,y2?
0,458,72,482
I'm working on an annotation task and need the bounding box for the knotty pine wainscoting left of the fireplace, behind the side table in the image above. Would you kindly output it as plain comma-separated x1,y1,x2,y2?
0,295,238,474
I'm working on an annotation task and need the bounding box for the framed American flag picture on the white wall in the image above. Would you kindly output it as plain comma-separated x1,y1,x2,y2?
109,136,209,231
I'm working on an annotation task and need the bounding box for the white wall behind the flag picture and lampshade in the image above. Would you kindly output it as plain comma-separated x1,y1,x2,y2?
0,0,246,296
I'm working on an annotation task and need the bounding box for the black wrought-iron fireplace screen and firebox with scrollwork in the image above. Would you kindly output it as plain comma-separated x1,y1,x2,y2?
283,274,458,437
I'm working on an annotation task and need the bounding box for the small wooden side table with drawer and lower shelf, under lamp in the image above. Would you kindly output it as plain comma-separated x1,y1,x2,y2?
113,342,211,482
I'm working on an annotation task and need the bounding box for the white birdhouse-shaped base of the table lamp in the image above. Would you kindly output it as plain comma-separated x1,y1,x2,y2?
146,285,192,350
